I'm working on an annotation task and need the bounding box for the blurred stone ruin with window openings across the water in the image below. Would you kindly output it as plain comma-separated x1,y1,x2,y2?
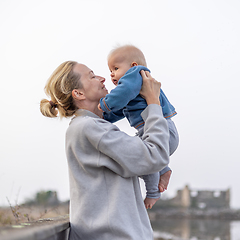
155,185,230,209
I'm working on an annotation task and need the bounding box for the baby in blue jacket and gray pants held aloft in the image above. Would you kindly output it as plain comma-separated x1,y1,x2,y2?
99,45,179,209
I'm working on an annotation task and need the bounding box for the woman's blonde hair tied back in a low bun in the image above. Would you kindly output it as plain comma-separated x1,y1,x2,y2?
40,61,82,118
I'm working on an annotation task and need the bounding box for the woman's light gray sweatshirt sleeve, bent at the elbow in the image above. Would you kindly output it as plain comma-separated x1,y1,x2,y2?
83,104,169,177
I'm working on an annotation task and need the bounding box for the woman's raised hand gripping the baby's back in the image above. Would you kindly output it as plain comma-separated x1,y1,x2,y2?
140,70,161,105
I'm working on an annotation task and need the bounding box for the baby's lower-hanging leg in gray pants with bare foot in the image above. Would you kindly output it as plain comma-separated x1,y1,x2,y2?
142,173,160,209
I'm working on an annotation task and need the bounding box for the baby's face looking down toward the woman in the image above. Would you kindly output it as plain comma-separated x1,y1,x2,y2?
108,55,131,85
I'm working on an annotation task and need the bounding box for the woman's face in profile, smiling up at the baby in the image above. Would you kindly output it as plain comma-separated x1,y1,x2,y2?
73,63,108,103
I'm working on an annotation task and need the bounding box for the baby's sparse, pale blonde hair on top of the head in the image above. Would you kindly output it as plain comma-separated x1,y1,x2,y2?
108,45,147,67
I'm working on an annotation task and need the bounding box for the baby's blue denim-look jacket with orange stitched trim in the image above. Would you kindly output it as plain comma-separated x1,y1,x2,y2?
100,65,177,129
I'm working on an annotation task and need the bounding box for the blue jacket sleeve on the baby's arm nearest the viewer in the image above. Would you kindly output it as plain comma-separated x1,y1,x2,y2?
100,66,149,113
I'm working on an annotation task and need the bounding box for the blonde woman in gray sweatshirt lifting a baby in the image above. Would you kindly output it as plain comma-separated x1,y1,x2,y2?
41,62,169,240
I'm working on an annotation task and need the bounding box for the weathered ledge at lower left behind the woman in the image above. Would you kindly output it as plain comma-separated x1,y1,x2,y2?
0,215,70,240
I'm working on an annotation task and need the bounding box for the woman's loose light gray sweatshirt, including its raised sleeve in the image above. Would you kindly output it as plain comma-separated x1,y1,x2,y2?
66,104,169,240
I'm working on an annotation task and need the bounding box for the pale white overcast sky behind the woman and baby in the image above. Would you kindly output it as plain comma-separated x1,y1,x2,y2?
0,0,240,208
